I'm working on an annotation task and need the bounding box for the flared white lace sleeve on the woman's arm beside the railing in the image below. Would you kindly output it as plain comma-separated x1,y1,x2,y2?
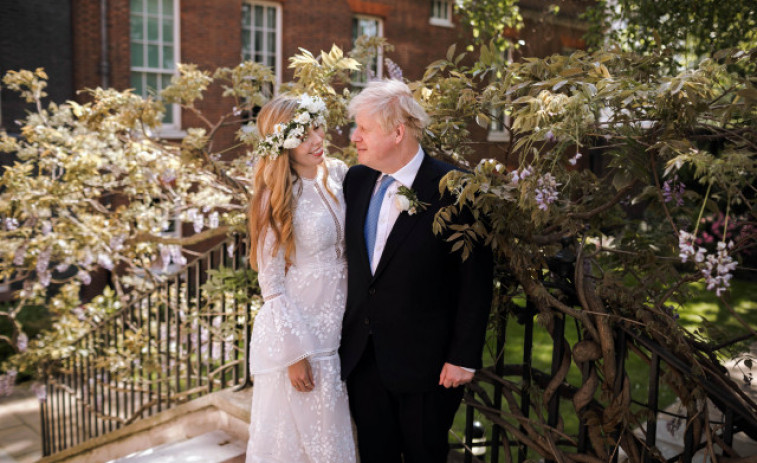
250,229,317,374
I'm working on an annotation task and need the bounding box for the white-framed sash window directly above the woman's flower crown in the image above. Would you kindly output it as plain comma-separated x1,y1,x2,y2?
242,2,281,82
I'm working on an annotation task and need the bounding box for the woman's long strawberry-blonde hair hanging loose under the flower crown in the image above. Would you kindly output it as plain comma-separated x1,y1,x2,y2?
248,95,336,270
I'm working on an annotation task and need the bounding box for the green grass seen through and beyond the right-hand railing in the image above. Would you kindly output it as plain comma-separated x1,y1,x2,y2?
452,280,757,456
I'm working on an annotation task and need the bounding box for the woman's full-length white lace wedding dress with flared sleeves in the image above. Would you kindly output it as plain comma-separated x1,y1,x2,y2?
247,159,355,463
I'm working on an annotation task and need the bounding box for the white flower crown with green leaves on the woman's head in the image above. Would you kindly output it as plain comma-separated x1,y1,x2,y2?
255,93,328,160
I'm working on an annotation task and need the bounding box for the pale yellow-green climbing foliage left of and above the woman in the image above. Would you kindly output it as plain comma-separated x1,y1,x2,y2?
0,47,359,374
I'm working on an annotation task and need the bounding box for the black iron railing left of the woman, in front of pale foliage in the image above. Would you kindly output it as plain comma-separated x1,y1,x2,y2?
41,237,252,455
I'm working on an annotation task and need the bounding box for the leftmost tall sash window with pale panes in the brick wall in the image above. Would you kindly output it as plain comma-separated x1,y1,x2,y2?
130,0,181,136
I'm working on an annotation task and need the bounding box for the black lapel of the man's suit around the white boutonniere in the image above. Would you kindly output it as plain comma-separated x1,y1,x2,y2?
370,154,439,280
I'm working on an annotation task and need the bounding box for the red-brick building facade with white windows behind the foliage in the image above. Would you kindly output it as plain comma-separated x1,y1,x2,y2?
0,0,588,152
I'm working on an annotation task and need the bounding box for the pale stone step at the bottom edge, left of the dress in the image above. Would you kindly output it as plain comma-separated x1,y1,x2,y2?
108,430,247,463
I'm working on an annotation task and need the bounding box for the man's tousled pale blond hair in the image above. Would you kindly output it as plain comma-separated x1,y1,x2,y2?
348,79,429,141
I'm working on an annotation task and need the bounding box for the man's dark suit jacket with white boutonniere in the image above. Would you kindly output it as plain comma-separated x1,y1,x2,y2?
339,155,493,392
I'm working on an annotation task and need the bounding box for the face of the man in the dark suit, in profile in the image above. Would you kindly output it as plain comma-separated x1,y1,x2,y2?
350,112,401,173
